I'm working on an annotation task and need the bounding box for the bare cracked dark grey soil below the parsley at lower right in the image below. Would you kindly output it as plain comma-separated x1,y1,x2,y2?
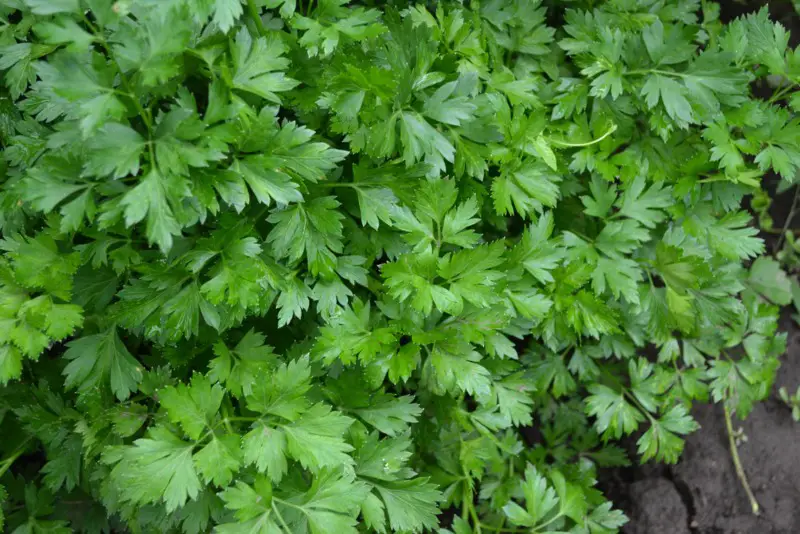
608,318,800,534
